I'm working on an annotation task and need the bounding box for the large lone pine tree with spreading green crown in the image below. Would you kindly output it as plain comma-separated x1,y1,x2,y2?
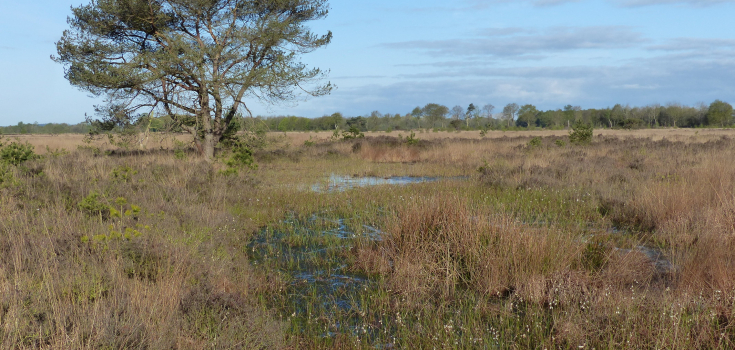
53,0,332,160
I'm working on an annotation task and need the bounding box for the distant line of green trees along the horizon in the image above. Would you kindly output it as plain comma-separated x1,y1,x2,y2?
0,100,735,134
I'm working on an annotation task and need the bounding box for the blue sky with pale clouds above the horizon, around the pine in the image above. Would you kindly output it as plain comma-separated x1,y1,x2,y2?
0,0,735,126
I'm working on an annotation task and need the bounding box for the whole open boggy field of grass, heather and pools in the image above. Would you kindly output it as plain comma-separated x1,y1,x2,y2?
0,129,735,349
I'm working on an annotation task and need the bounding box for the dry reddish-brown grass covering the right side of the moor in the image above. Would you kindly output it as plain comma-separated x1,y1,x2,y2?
344,131,735,348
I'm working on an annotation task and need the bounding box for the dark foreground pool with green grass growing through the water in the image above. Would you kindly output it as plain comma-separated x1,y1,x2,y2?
249,215,380,344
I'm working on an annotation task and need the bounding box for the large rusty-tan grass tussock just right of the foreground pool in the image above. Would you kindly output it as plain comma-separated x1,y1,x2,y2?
385,194,584,302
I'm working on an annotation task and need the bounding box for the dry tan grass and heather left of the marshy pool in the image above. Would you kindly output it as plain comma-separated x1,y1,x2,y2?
0,151,284,349
